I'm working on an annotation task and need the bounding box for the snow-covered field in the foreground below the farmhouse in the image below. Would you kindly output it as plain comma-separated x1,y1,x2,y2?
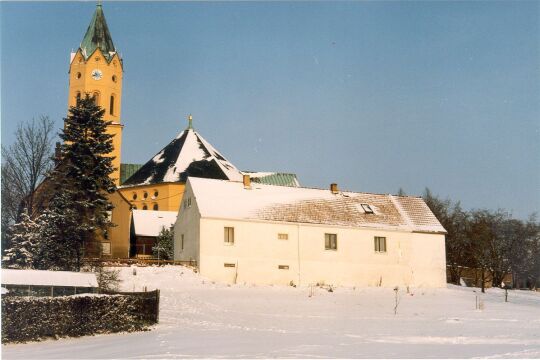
2,266,540,359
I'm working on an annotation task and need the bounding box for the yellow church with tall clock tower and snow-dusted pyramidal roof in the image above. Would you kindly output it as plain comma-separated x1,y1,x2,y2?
68,3,299,258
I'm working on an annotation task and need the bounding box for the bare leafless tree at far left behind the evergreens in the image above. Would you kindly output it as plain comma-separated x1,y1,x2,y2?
2,116,55,225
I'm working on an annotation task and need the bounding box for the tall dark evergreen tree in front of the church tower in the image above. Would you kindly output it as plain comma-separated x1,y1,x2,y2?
41,95,115,271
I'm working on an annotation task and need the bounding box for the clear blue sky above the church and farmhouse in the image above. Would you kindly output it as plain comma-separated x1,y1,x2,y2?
0,1,540,218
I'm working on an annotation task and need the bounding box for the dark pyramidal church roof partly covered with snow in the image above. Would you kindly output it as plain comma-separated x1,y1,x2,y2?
122,126,242,186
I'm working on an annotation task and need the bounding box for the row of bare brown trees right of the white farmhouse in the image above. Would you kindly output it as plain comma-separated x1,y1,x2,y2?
418,189,540,290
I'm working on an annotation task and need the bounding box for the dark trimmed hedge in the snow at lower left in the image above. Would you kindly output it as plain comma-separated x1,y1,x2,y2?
2,290,159,343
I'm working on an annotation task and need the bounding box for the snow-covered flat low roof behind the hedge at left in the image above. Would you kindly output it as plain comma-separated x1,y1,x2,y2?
2,269,98,287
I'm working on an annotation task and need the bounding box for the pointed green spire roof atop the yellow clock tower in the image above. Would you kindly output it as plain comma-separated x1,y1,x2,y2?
81,2,116,60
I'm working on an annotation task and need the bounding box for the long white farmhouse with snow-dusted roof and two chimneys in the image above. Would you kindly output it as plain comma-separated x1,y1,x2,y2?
174,175,446,287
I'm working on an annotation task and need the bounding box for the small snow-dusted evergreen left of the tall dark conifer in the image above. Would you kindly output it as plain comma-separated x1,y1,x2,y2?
3,210,39,269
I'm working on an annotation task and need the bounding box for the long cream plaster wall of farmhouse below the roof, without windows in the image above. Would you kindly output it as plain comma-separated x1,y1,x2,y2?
196,219,446,287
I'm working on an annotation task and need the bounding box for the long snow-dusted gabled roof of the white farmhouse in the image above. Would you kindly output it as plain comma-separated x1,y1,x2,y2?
188,177,446,233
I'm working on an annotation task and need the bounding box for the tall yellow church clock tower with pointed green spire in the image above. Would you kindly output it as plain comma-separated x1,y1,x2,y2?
68,2,123,186
